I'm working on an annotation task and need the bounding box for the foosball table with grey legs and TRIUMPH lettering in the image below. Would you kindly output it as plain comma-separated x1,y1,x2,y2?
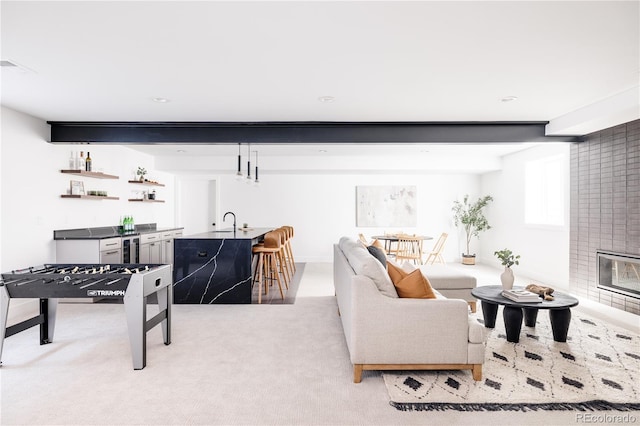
0,264,173,370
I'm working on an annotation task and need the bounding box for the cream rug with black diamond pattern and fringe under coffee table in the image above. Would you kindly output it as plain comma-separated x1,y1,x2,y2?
383,309,640,411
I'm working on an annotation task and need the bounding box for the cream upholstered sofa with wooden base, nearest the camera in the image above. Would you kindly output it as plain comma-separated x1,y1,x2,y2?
333,237,485,383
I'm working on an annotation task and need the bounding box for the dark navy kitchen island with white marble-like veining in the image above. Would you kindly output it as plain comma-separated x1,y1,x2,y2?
173,228,274,304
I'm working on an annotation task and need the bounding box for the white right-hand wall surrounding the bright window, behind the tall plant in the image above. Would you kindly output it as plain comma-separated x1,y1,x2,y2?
478,144,570,290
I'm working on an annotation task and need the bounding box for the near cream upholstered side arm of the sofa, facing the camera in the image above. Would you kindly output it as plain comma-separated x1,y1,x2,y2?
349,276,476,364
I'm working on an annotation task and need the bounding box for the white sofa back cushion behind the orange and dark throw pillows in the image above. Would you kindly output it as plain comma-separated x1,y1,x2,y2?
338,237,398,298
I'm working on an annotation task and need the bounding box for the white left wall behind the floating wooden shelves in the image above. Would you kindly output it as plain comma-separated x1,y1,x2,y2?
0,107,179,272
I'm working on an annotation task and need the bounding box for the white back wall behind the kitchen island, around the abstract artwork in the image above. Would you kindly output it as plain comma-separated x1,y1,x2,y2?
172,173,479,262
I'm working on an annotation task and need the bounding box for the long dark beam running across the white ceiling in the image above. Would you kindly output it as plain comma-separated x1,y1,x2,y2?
47,121,580,144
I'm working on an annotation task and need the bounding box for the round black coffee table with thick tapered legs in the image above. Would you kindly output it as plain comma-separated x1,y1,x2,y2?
471,285,578,343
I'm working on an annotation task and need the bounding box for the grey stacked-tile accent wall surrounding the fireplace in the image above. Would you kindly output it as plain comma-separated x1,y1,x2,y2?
569,120,640,315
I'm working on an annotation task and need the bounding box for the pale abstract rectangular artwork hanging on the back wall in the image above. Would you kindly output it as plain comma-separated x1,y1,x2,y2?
356,185,418,227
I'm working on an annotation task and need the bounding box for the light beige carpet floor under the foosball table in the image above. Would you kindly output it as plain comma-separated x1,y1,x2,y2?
0,264,640,425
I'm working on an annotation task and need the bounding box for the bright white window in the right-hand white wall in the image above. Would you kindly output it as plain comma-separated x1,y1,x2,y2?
524,155,565,226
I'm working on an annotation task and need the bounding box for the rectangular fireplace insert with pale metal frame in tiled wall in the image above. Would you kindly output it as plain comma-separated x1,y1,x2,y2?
596,250,640,299
